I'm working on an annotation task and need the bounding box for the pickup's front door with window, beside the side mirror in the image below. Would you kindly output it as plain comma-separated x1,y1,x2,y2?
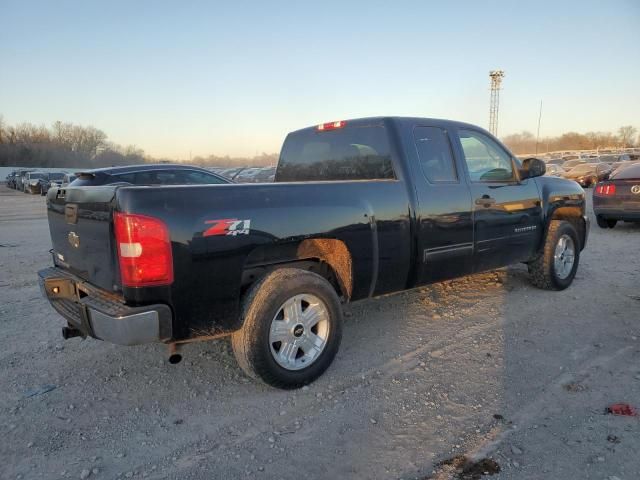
456,128,543,271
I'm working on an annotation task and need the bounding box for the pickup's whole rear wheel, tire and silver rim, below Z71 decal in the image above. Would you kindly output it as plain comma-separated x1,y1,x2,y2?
231,268,342,389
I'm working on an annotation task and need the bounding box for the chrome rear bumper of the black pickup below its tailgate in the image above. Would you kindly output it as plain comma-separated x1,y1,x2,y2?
38,267,173,345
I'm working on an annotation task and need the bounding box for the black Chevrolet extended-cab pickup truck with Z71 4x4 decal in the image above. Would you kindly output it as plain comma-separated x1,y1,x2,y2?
39,117,589,388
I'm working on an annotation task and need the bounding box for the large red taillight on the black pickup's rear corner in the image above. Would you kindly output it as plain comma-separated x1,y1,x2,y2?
113,212,173,287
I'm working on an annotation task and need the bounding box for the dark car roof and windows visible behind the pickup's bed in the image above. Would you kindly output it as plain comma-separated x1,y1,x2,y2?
70,163,232,187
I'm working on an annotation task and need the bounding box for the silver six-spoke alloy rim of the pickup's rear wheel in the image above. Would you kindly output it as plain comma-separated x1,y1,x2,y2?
269,294,330,370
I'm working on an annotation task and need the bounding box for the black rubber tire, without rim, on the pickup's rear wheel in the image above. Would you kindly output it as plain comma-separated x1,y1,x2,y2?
231,268,342,389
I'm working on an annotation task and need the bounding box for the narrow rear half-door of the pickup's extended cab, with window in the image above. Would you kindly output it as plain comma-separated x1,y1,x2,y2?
408,124,473,284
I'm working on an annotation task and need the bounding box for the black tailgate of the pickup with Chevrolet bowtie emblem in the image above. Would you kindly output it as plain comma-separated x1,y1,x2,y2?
47,186,120,291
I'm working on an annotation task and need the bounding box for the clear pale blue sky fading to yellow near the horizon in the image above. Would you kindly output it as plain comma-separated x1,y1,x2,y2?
0,0,640,160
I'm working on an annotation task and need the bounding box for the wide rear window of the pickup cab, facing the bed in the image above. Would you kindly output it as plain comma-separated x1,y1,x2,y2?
275,121,396,182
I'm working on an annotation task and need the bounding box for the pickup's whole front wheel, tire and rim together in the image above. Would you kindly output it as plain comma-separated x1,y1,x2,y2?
529,220,580,290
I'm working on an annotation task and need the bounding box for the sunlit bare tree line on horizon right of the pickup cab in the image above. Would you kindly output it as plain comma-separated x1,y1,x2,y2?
502,125,640,154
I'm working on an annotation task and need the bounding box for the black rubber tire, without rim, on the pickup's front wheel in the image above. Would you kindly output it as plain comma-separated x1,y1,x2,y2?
528,220,580,290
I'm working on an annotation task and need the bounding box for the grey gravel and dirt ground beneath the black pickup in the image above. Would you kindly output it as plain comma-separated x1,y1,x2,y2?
0,186,640,480
